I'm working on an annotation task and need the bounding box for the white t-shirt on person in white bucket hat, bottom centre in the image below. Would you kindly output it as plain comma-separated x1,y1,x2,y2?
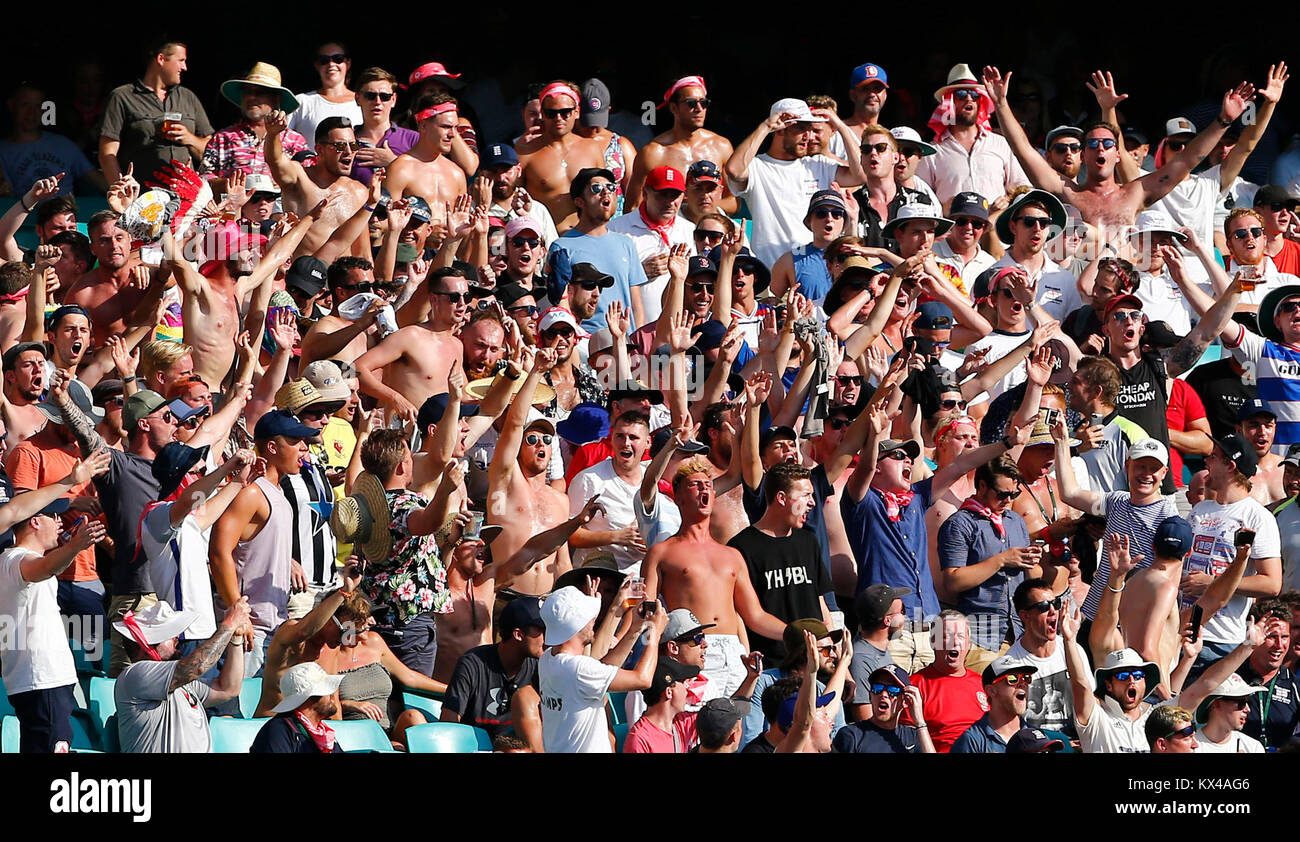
537,650,619,754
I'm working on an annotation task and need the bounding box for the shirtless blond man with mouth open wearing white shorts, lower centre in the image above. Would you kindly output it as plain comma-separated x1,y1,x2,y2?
642,459,785,695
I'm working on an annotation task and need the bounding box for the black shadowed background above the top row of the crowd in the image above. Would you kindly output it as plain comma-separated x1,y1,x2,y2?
0,9,1300,181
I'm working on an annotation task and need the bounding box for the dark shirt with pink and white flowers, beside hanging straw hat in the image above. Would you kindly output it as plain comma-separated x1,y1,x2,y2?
361,490,451,626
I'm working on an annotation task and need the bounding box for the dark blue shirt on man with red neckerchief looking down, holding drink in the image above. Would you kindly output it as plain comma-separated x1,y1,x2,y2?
939,509,1030,652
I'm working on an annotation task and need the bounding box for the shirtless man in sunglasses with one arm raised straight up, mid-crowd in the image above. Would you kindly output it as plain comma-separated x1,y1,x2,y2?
488,348,572,595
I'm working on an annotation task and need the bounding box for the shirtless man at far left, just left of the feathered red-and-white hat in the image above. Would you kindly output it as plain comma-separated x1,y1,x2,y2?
64,211,150,344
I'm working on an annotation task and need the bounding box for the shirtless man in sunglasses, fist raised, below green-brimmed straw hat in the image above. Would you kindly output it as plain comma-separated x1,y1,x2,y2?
264,110,368,257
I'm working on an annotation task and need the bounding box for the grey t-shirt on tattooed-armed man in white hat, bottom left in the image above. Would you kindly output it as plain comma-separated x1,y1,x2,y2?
113,660,212,754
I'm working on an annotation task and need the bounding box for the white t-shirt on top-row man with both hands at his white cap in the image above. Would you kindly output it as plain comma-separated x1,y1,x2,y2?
727,152,840,268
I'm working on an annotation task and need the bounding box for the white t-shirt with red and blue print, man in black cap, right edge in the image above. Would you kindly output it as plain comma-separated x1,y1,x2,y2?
1179,498,1282,643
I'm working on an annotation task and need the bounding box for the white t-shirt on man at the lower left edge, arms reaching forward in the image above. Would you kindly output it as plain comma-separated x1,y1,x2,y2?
0,547,77,695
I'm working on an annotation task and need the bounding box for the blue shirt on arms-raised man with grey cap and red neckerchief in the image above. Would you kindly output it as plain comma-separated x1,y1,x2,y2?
840,477,939,620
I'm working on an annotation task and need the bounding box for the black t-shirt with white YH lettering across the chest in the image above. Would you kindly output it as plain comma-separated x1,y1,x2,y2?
727,526,833,660
